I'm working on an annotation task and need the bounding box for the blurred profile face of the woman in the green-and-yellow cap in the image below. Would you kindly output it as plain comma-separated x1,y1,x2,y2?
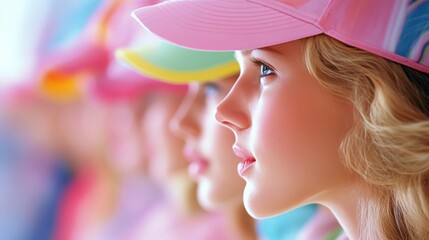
172,76,244,210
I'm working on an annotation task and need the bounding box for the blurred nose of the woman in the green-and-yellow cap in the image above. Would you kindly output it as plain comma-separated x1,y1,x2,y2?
169,89,200,138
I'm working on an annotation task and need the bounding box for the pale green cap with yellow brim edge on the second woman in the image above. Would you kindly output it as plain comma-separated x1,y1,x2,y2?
115,40,240,84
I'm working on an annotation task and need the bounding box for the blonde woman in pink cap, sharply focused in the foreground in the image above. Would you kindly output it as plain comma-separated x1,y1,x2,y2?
134,0,429,240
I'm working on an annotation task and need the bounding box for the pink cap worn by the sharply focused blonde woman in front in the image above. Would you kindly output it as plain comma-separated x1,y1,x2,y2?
132,0,429,72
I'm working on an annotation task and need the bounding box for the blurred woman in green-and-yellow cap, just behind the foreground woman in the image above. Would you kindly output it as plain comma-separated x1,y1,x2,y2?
117,41,257,239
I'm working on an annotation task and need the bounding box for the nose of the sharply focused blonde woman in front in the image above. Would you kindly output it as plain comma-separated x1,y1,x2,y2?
216,78,251,132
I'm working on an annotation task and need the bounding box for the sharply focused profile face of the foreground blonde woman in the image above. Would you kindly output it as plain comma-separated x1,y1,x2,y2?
217,41,354,217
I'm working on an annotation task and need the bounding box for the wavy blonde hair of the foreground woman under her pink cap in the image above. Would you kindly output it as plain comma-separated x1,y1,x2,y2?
304,34,429,240
